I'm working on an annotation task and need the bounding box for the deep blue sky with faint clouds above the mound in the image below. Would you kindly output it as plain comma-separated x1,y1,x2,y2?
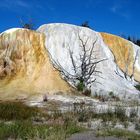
0,0,140,37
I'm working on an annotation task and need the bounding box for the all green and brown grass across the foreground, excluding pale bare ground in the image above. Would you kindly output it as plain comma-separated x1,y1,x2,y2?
0,102,140,140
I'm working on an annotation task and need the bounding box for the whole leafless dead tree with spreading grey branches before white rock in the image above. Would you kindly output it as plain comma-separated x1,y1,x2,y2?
48,34,107,90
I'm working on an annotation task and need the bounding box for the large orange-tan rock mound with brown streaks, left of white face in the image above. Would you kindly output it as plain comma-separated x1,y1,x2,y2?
0,29,70,99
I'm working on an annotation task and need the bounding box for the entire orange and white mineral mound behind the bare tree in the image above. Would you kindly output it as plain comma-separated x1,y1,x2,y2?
0,24,140,99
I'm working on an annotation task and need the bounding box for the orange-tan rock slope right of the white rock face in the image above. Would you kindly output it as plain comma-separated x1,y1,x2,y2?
101,33,140,82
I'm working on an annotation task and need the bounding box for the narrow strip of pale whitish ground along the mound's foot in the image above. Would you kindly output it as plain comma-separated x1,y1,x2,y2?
26,95,140,116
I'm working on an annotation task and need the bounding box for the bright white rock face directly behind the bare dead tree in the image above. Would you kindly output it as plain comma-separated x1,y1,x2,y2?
37,24,140,98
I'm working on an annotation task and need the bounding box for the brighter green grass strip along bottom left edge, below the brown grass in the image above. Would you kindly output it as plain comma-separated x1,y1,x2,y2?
0,121,82,140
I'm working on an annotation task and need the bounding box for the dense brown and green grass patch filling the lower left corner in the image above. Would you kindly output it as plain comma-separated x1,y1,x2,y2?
0,102,84,140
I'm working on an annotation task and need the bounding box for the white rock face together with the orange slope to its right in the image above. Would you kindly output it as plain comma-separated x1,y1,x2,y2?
38,24,140,98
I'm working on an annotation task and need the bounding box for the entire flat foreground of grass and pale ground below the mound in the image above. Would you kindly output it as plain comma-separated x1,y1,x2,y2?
0,94,140,140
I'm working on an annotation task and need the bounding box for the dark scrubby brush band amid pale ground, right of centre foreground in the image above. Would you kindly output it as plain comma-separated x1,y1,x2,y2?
74,102,129,124
